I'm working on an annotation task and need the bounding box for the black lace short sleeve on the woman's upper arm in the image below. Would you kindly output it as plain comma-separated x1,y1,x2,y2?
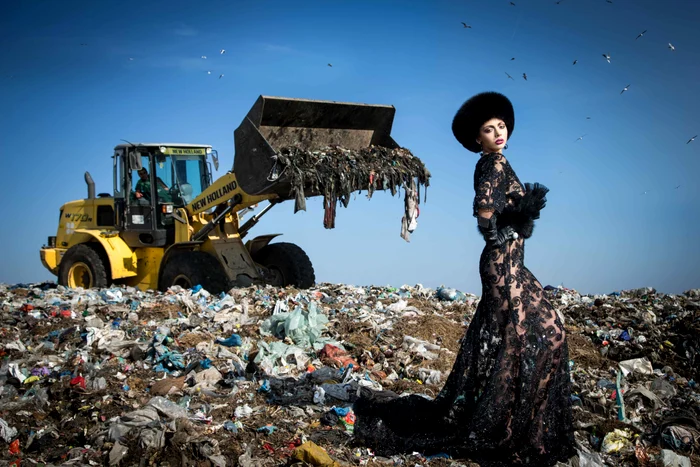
474,154,506,217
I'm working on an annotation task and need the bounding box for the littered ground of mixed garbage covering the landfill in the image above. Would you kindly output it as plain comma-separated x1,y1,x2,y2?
0,283,700,466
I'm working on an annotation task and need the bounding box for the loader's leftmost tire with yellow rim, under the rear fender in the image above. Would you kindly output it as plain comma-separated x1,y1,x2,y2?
58,244,109,289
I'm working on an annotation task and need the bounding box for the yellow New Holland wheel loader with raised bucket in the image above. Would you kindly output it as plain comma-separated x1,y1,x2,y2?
41,96,422,293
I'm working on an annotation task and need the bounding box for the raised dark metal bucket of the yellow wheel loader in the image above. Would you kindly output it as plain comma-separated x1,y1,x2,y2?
233,96,398,197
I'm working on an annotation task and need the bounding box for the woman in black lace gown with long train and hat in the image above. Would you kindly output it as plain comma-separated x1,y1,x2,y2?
355,93,575,466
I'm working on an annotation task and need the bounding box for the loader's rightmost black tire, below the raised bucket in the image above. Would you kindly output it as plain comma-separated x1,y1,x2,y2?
253,242,316,289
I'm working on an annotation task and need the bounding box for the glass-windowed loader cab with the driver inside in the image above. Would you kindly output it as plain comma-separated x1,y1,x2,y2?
114,143,218,248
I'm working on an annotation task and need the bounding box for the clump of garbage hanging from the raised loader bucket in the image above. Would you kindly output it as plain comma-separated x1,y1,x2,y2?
270,146,430,240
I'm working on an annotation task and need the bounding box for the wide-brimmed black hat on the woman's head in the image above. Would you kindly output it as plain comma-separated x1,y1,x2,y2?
452,92,515,152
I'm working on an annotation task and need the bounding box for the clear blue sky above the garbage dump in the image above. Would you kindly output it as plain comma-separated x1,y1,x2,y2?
0,0,700,294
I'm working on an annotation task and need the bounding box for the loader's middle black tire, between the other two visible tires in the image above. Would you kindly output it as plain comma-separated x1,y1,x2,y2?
160,251,229,294
